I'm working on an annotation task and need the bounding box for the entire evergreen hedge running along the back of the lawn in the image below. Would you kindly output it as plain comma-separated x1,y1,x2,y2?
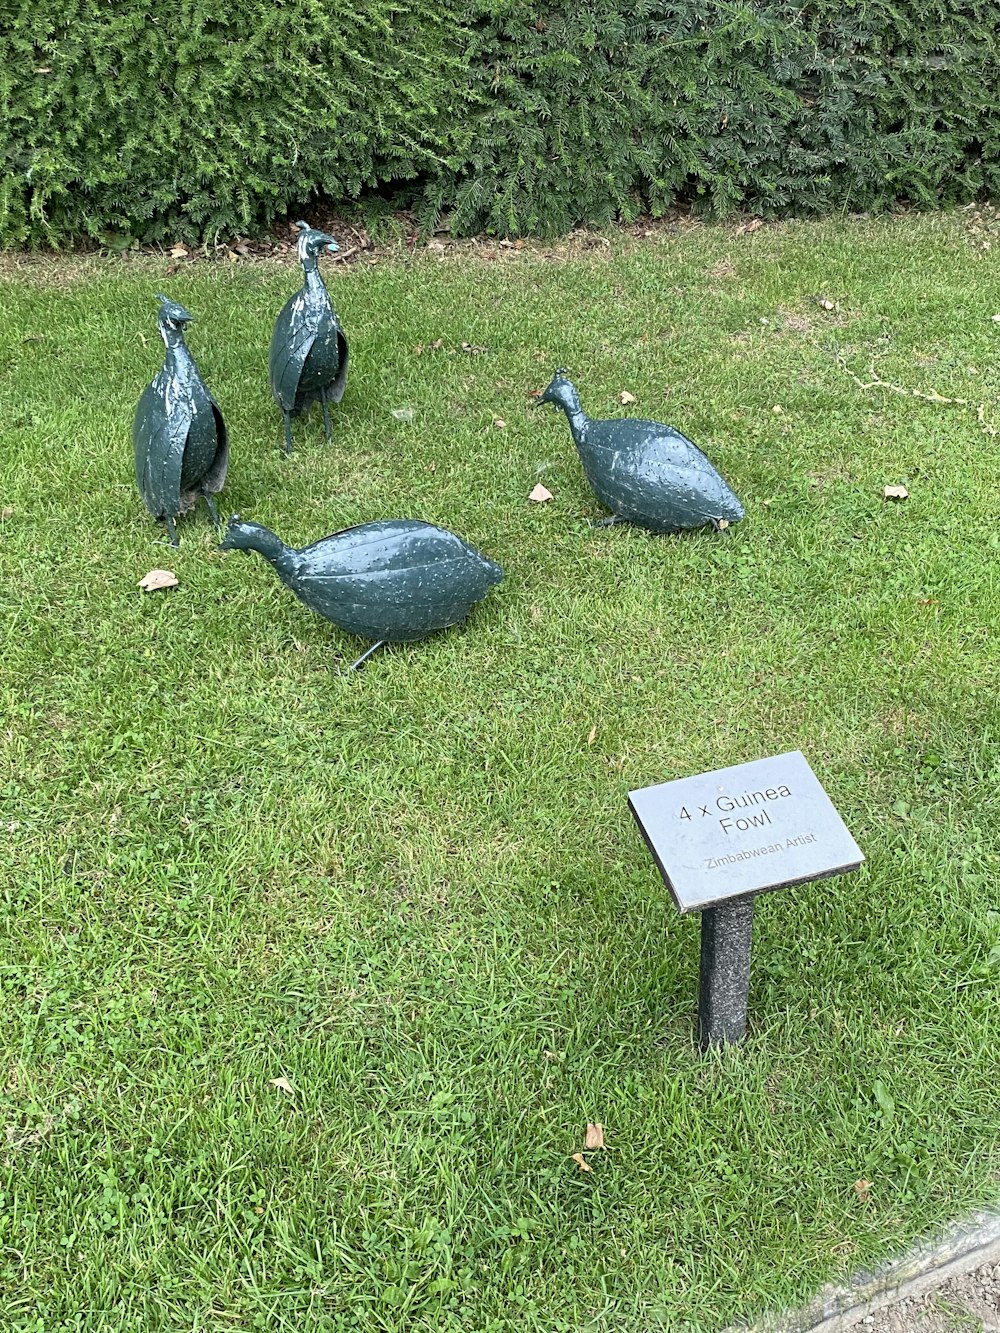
0,0,1000,244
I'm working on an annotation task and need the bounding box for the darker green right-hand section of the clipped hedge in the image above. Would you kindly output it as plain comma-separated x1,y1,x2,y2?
442,0,1000,232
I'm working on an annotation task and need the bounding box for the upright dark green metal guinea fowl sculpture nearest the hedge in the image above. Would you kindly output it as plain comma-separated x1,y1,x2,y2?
268,215,348,453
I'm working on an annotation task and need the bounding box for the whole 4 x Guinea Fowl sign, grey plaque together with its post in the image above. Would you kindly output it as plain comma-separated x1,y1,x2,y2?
628,750,864,1050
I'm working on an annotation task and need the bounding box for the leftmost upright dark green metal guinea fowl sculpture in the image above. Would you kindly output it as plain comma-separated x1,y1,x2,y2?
132,296,229,547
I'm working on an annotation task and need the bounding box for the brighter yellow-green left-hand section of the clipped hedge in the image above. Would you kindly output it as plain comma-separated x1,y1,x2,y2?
0,0,469,244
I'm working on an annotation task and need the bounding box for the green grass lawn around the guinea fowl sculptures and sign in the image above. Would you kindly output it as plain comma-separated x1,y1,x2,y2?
0,215,1000,1333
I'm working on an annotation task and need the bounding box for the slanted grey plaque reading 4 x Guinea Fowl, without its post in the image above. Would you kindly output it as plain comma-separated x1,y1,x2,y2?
628,750,864,912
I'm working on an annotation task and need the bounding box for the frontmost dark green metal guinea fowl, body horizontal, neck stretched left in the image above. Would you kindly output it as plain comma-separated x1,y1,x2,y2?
221,515,504,670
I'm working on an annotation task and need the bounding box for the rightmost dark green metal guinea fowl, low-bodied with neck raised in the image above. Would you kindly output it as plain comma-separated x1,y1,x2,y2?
536,369,744,532
